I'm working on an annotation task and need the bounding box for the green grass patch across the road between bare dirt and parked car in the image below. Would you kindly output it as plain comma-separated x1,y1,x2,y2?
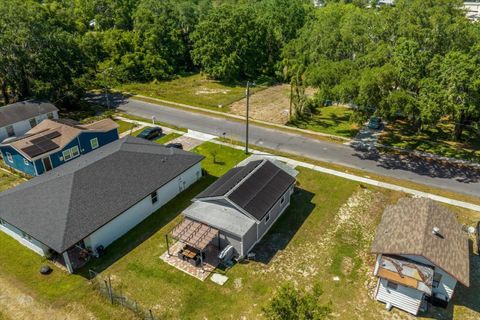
288,106,358,138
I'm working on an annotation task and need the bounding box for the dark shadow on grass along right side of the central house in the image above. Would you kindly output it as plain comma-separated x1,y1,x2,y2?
252,188,315,264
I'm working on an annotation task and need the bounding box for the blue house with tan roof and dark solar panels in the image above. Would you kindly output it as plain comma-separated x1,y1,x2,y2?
0,119,118,176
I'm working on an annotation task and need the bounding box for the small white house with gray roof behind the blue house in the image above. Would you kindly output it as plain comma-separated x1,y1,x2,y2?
0,100,58,142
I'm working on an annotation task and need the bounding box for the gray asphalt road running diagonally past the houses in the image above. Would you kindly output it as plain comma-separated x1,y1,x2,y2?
90,97,480,196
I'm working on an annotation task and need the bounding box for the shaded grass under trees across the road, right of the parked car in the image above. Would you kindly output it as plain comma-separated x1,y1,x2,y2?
379,121,480,162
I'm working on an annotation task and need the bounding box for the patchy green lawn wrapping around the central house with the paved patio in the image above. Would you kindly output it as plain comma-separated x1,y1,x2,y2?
78,143,424,319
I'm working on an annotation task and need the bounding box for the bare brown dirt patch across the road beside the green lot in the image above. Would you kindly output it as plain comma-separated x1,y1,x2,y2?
230,84,313,124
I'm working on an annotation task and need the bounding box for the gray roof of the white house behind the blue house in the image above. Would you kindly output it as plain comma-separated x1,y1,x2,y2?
0,100,58,128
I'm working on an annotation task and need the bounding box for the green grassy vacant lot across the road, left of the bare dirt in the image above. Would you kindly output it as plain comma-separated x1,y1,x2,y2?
117,74,264,111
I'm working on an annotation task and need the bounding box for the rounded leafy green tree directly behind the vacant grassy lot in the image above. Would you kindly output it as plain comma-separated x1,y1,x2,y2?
191,4,280,81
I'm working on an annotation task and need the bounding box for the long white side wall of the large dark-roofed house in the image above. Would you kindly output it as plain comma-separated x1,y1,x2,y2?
84,163,202,249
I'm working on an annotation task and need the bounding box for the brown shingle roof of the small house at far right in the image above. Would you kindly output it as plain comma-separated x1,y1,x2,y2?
372,198,470,286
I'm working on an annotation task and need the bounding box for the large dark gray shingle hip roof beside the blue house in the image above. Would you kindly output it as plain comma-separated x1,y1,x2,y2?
0,137,203,252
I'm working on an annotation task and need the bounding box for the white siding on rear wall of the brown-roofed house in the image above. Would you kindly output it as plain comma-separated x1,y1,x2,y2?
376,278,423,315
